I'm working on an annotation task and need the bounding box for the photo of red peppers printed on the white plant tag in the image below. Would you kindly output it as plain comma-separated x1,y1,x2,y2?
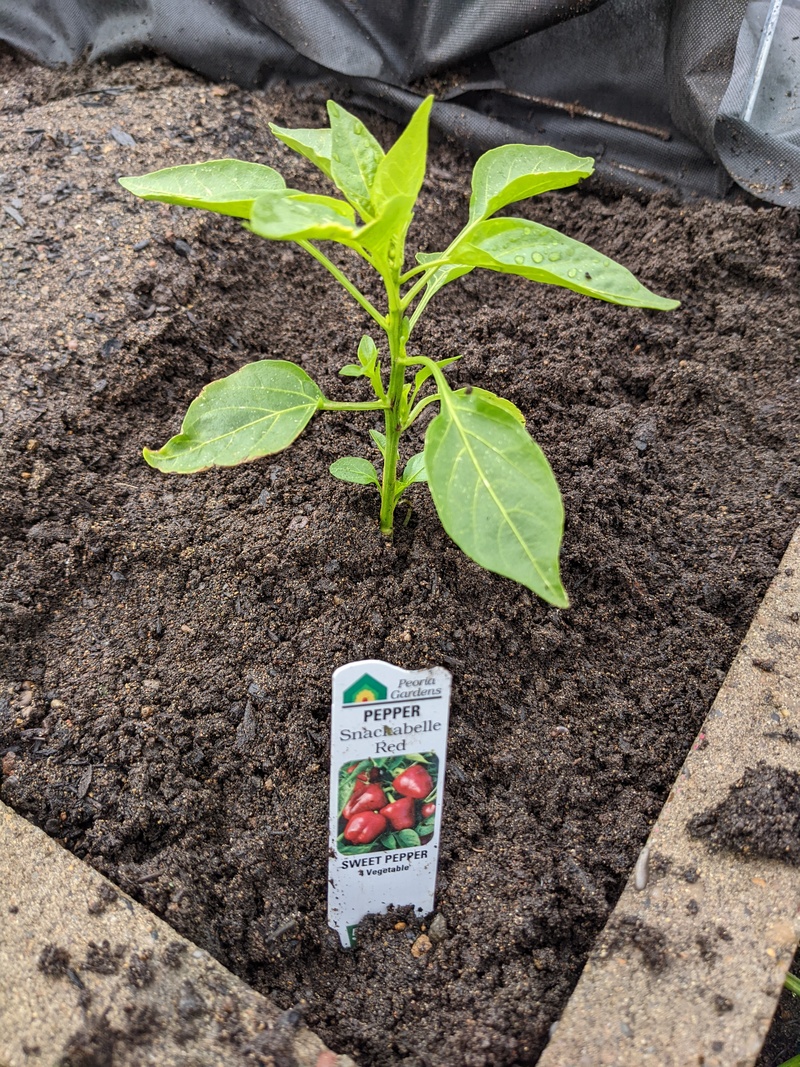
336,752,438,856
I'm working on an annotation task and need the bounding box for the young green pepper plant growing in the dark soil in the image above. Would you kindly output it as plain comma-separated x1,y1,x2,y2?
119,97,677,607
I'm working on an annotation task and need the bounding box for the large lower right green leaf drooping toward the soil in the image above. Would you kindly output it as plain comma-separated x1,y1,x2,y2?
425,389,569,607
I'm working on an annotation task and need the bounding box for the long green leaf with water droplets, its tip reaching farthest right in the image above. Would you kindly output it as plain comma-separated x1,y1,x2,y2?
449,219,679,312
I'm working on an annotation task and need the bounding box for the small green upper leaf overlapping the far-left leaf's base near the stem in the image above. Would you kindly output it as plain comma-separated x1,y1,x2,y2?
245,189,355,244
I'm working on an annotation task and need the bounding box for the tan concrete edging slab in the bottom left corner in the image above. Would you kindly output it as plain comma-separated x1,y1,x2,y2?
0,803,355,1067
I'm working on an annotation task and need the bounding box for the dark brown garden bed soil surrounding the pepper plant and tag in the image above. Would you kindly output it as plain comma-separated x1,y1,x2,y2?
0,57,800,1067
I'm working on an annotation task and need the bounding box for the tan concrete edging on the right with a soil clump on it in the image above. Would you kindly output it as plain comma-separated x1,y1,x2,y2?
539,530,800,1067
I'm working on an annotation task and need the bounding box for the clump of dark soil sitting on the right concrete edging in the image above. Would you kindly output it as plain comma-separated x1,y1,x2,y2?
687,762,800,866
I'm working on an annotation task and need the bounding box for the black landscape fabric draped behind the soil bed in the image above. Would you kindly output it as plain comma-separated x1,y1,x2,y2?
0,0,800,207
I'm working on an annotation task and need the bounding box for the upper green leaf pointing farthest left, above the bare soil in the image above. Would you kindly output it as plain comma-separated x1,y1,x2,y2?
119,159,286,219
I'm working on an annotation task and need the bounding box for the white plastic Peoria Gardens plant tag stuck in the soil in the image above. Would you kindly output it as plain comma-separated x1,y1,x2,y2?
327,659,452,949
